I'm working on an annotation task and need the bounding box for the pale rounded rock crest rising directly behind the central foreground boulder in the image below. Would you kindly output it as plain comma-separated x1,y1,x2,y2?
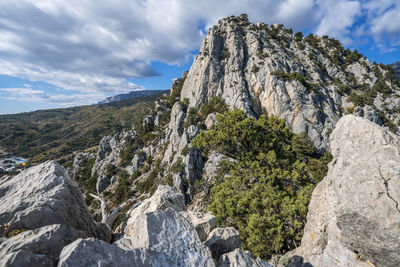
125,185,185,235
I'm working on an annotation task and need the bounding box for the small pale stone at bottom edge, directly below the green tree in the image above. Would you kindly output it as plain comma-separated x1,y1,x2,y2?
218,248,273,267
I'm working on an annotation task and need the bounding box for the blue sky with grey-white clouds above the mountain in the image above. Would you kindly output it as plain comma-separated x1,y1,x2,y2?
0,0,400,114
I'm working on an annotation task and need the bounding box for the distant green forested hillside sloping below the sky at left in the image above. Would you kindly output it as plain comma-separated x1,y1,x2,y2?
0,95,159,162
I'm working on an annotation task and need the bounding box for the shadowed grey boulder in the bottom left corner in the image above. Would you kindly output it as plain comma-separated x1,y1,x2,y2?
0,224,87,267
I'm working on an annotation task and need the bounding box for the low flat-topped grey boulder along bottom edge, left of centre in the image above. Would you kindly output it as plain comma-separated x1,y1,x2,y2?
58,238,178,267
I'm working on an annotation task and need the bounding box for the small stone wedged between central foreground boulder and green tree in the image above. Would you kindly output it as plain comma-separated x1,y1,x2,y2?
180,211,217,242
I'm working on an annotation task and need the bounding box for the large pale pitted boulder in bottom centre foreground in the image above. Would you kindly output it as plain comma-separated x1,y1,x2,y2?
129,209,215,266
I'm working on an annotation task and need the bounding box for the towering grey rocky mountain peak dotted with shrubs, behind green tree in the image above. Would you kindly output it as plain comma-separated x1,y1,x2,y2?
180,15,400,150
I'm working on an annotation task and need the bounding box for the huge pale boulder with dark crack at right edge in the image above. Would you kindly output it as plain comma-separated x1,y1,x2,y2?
290,115,400,266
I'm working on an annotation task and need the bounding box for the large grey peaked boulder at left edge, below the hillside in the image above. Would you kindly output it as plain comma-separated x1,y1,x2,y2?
0,161,108,241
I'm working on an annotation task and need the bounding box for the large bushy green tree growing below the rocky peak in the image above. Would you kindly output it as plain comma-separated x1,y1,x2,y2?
192,110,331,259
